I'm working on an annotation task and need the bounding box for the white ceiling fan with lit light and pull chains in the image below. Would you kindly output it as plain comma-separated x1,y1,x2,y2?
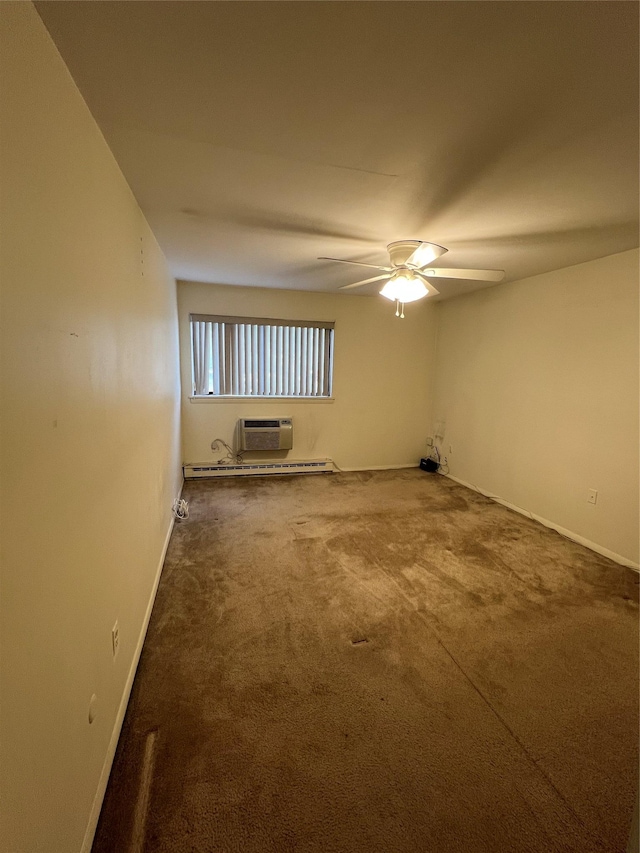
318,240,505,317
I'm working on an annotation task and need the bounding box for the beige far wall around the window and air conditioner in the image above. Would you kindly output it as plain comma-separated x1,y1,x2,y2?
178,282,435,469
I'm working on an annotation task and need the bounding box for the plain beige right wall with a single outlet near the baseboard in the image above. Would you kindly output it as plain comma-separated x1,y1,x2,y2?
434,250,638,562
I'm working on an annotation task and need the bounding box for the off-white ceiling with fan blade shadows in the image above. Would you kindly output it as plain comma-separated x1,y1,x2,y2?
36,0,638,298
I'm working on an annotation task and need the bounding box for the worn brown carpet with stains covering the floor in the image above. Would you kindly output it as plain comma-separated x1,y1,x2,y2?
93,469,638,853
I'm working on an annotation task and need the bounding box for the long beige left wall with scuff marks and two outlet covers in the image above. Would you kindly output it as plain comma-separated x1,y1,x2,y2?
0,3,181,853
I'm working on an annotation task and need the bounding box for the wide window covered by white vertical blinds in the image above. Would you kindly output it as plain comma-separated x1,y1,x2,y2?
191,314,334,398
